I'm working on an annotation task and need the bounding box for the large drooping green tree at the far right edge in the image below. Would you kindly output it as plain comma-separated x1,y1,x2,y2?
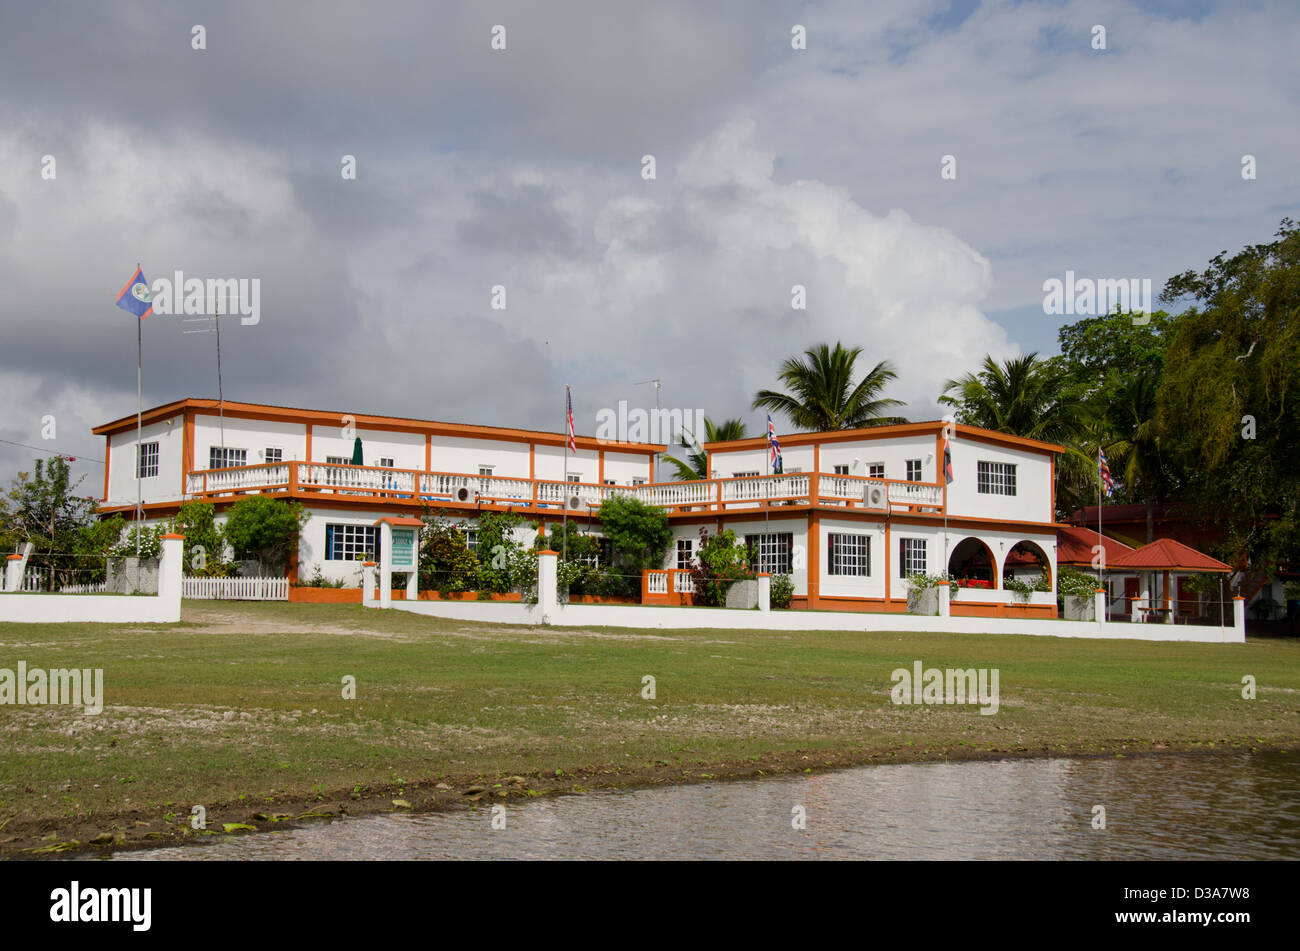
1158,218,1300,598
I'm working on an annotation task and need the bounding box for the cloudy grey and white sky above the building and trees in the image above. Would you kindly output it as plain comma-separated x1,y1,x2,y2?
0,0,1300,490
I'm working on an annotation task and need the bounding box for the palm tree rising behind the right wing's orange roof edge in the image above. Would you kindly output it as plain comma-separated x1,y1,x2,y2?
754,343,906,433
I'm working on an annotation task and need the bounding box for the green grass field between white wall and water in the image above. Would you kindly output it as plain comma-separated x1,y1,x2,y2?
0,602,1300,855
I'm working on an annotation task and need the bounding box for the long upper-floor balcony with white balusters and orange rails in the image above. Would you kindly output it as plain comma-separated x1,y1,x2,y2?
170,461,946,514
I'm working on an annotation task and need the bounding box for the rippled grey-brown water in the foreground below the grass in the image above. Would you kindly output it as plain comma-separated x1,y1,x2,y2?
104,754,1300,860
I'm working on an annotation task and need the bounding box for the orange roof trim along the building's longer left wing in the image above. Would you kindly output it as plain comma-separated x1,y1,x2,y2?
91,398,668,452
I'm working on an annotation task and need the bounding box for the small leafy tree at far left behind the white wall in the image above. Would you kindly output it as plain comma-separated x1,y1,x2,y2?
0,456,96,590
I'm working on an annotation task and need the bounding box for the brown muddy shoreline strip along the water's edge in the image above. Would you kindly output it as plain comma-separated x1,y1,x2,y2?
0,743,1290,861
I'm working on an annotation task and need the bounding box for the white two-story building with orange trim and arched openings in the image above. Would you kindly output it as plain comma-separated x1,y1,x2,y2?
95,399,1061,615
